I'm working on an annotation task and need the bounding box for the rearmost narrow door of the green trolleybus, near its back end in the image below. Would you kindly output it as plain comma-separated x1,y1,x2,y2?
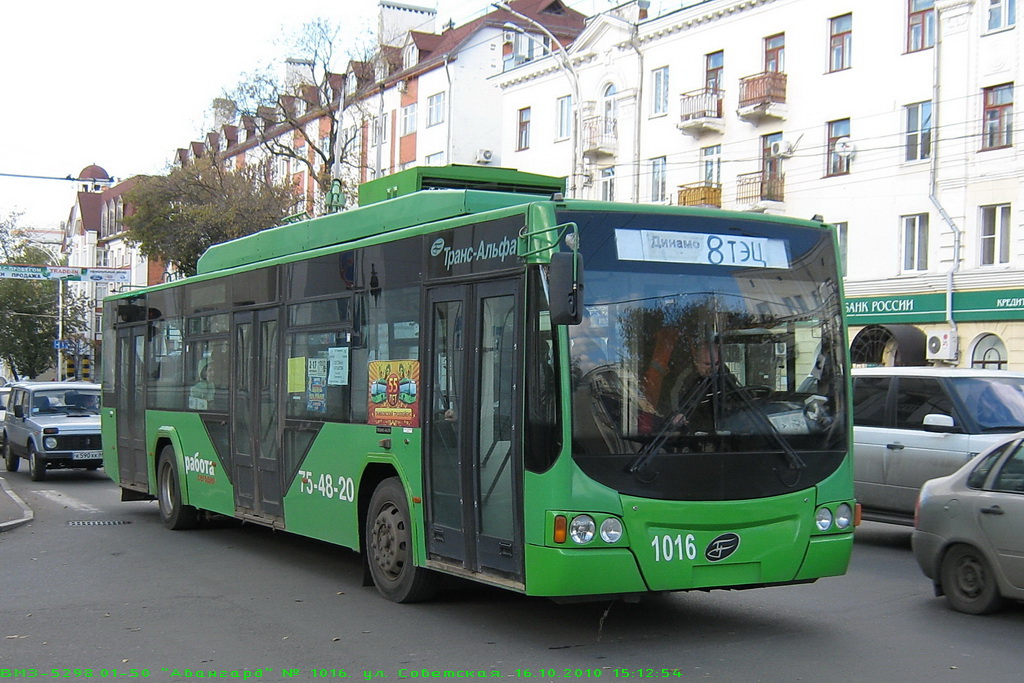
117,325,150,490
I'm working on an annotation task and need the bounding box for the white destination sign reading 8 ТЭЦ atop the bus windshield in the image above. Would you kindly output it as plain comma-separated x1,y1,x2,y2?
615,228,790,268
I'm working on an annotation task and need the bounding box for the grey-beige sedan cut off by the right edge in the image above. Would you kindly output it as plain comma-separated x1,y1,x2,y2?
912,432,1024,614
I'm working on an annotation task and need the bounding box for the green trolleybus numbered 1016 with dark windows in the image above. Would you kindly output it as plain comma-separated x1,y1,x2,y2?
102,167,855,602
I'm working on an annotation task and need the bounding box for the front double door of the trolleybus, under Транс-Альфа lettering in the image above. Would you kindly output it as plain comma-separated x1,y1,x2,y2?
424,281,523,582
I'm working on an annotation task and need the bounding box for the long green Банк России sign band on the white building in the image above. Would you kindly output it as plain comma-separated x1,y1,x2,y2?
846,290,1024,325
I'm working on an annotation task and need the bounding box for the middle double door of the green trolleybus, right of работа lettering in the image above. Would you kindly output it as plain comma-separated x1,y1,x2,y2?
230,308,283,523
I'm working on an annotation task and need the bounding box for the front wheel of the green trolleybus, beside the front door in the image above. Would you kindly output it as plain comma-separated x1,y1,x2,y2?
366,477,437,602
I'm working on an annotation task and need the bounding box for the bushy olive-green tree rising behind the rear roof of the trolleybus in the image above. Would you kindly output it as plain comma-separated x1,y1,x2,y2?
125,154,292,275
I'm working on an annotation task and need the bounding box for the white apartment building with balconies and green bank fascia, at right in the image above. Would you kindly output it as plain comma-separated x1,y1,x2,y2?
492,0,1024,370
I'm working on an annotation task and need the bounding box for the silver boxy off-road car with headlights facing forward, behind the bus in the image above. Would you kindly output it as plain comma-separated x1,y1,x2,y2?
3,382,103,481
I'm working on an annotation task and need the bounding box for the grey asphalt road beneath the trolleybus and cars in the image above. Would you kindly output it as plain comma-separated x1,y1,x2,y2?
0,472,1024,681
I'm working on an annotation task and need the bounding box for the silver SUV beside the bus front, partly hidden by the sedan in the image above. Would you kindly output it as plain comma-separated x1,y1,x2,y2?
853,368,1024,524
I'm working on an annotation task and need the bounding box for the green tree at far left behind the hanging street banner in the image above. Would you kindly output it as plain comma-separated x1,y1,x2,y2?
0,211,86,380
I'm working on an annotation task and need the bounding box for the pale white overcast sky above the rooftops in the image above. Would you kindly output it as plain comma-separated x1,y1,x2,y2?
0,0,617,230
